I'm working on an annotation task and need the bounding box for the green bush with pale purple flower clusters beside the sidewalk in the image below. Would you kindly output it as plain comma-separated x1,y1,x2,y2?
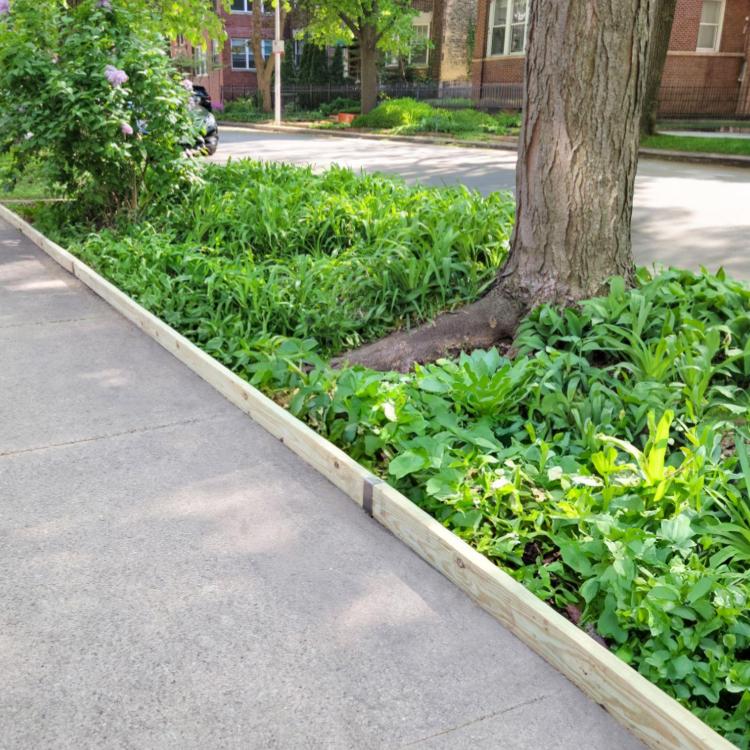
0,0,195,221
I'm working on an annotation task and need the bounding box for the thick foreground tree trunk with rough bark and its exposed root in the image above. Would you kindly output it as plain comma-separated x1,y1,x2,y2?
343,0,657,370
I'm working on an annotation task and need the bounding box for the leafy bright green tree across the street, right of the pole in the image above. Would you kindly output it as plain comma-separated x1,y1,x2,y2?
302,0,416,113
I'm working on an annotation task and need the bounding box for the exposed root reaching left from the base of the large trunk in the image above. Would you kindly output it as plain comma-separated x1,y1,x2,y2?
333,286,525,372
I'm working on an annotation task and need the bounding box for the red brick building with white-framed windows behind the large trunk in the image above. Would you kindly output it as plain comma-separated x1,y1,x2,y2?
472,0,750,116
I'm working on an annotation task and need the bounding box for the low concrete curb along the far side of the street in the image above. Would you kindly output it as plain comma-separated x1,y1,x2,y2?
219,120,750,168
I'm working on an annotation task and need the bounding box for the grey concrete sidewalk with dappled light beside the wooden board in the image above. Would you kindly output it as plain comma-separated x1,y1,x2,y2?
0,222,641,750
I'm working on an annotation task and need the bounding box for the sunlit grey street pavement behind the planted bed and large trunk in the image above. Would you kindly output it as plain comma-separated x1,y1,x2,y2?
213,127,750,280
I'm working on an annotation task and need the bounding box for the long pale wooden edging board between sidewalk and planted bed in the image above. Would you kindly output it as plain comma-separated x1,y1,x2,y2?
0,204,735,750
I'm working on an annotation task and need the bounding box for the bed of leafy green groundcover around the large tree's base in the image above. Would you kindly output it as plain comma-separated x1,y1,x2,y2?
38,163,750,750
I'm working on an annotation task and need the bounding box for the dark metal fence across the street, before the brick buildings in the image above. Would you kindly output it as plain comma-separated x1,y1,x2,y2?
222,81,750,119
